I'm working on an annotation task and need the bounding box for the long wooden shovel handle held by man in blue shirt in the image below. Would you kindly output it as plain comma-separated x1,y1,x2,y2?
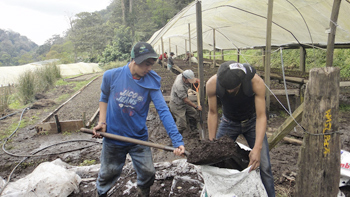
80,128,190,156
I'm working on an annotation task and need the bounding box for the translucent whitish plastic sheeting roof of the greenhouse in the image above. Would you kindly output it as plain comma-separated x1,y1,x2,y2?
148,0,350,55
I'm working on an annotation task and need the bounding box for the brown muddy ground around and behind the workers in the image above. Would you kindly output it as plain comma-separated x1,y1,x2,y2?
0,59,350,197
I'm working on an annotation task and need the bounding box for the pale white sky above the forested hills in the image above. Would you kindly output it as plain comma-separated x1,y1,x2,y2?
0,0,112,45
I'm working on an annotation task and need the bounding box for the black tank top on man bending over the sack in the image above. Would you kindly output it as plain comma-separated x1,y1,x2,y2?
216,81,255,121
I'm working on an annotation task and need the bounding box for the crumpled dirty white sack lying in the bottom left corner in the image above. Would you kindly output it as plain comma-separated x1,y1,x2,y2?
1,159,81,197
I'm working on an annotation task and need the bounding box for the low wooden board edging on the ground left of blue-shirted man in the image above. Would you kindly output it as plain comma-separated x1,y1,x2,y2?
35,120,84,134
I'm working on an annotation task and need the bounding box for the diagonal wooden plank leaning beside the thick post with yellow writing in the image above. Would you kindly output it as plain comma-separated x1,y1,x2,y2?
267,103,304,150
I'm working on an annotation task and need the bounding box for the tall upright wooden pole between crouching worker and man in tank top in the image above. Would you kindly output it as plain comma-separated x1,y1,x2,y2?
196,1,207,139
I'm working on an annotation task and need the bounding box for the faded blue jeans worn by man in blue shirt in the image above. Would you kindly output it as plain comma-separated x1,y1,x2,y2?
96,140,156,195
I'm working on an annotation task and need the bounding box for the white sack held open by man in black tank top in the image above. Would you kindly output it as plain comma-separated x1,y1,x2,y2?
201,165,267,197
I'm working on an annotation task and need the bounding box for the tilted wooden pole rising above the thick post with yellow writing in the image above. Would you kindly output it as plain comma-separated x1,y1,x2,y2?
326,0,341,66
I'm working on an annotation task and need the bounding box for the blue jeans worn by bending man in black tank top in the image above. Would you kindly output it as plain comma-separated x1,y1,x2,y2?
216,116,275,197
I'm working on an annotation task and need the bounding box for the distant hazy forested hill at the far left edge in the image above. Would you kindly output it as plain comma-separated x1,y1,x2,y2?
0,29,38,66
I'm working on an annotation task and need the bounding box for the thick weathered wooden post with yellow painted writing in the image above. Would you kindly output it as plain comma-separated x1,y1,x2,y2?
295,67,340,197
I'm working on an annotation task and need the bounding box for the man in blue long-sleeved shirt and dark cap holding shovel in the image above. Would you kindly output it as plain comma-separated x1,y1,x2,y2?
93,42,185,196
